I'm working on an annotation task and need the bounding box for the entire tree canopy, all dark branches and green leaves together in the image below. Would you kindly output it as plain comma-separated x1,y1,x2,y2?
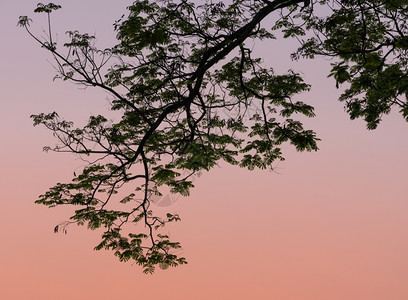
18,0,408,273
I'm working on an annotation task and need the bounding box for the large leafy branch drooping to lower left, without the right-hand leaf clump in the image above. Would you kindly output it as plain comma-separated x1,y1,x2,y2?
20,0,318,272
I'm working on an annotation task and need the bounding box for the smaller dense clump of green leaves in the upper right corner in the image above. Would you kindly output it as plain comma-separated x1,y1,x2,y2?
286,0,408,129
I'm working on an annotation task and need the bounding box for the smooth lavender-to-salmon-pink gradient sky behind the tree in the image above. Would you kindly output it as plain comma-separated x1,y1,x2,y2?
0,0,408,300
